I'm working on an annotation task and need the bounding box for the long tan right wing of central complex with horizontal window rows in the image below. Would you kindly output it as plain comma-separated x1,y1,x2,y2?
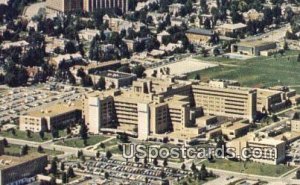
192,80,256,121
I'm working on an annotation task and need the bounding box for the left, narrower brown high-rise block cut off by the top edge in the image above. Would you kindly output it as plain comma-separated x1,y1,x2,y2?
46,0,82,13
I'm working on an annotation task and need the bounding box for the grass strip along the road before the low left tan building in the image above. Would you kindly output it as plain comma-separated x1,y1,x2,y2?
0,130,66,142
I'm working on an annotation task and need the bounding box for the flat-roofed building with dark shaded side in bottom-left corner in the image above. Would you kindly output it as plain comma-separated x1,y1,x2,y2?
0,153,48,184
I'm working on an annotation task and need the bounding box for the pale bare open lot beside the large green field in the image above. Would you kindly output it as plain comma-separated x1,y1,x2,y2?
145,58,217,76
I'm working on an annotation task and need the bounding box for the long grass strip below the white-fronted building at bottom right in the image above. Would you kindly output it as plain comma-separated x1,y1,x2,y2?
203,159,294,177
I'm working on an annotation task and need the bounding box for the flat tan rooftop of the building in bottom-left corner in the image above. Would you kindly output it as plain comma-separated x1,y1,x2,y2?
0,153,46,170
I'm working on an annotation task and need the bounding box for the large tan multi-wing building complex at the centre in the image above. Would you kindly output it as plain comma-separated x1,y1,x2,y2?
82,77,300,140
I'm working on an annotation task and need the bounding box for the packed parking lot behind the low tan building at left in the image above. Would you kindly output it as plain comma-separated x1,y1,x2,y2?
0,84,87,124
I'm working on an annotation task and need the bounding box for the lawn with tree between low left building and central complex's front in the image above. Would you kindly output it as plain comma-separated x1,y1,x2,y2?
56,135,108,148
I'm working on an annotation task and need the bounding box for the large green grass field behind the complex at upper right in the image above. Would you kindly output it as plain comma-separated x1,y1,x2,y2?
189,50,300,90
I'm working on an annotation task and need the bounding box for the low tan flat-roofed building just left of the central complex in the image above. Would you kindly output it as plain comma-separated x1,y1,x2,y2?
19,101,82,132
